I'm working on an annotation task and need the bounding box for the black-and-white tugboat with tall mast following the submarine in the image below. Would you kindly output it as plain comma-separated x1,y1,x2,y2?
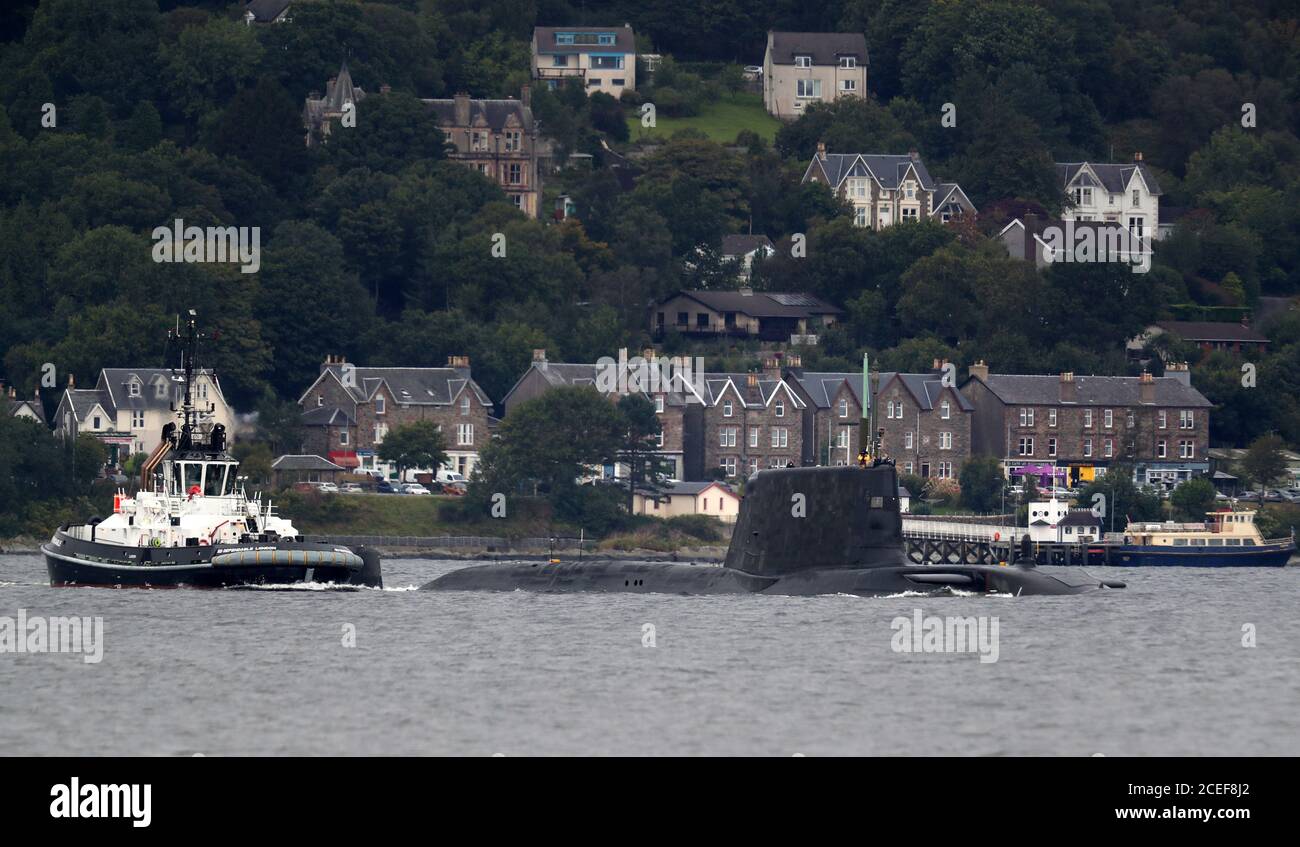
40,309,384,588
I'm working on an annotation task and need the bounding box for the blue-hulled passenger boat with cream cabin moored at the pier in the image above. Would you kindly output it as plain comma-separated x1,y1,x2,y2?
1112,509,1296,568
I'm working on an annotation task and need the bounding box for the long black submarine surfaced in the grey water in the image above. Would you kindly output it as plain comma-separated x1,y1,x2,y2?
421,460,1125,596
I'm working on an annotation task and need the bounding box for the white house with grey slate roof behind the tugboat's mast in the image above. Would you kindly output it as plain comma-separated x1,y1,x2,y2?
53,368,235,468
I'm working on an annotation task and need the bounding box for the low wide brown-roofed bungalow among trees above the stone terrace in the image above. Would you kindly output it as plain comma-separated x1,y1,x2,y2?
650,288,844,343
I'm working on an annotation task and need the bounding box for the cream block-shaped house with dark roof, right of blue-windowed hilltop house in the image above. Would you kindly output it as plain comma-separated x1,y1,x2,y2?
763,31,867,121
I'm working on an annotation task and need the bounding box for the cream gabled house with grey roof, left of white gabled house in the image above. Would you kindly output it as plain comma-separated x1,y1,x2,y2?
803,143,976,230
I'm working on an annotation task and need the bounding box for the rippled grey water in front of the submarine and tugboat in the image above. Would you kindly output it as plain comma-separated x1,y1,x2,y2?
0,556,1300,756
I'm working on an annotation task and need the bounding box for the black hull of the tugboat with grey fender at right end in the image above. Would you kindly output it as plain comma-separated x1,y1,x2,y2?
40,530,384,588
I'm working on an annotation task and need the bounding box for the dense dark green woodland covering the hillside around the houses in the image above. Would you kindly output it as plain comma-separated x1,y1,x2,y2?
0,0,1300,462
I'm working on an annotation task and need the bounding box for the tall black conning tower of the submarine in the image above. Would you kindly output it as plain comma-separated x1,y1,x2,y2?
727,465,909,577
